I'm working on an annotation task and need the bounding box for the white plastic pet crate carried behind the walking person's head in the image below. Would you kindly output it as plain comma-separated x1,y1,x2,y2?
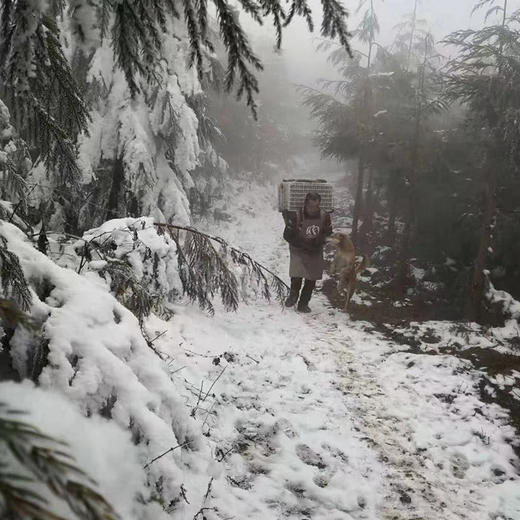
278,179,334,212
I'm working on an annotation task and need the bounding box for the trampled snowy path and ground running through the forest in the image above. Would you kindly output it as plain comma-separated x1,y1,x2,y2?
148,170,520,520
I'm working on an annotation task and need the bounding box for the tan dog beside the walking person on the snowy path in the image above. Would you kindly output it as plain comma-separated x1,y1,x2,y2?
327,233,369,310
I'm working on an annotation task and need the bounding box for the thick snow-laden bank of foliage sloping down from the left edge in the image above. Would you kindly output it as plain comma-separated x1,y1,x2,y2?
0,222,201,500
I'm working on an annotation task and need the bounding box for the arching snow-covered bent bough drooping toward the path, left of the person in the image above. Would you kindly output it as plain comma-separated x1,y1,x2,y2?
76,218,285,321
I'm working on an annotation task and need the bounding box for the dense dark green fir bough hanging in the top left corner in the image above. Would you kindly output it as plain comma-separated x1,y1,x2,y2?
0,5,89,179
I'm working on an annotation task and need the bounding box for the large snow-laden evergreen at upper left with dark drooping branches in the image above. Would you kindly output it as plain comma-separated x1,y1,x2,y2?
0,0,354,233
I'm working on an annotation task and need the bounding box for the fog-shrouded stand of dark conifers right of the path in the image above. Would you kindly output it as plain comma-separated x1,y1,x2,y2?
300,0,520,318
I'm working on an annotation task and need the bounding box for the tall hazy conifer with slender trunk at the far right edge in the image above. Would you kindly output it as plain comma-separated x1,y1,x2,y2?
445,0,520,318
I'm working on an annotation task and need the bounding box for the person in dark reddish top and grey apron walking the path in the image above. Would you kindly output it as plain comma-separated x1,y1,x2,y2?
283,192,332,312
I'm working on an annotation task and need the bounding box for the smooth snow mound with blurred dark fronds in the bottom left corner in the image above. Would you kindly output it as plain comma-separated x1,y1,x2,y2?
0,381,180,520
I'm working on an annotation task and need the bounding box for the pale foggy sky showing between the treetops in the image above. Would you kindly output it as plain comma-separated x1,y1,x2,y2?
246,0,520,85
